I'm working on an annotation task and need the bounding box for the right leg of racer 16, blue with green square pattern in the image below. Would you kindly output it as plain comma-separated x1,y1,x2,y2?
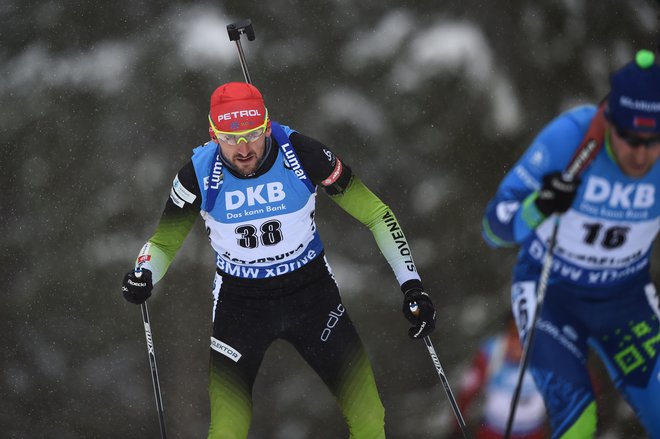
592,283,660,438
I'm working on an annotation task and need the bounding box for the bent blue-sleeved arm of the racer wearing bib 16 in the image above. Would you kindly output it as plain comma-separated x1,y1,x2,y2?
482,107,595,247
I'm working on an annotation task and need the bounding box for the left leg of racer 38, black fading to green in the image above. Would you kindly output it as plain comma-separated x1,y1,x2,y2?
208,276,274,439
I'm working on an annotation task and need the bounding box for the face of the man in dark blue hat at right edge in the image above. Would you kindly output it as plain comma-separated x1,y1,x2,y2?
609,123,660,178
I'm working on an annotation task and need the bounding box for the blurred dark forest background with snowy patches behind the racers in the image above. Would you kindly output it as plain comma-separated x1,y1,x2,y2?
0,0,658,439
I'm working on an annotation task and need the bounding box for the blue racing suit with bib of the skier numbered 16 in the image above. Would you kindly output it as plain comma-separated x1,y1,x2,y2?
482,106,660,438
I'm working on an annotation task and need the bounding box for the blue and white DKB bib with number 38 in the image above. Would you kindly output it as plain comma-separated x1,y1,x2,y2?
192,122,323,278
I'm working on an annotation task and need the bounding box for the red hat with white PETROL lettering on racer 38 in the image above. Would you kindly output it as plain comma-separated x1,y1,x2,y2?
209,82,267,137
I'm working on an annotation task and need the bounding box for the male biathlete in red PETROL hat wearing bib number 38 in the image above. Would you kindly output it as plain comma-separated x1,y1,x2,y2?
122,82,435,439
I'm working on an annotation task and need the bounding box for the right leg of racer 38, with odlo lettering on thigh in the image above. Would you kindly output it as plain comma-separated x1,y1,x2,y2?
284,277,385,439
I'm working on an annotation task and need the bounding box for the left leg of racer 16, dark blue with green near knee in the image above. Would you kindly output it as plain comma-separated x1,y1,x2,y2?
512,281,596,439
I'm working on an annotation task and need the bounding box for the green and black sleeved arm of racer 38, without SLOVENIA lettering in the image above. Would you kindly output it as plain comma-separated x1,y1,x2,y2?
135,161,202,284
